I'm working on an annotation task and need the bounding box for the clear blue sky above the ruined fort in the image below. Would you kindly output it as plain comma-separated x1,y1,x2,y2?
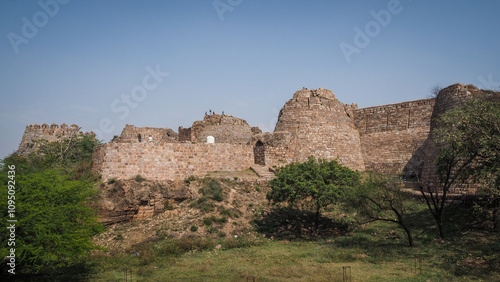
0,0,500,157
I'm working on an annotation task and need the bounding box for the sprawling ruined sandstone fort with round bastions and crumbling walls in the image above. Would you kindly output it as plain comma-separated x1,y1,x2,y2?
18,84,498,191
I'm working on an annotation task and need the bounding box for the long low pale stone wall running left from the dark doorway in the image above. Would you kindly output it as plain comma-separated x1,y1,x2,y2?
93,142,254,180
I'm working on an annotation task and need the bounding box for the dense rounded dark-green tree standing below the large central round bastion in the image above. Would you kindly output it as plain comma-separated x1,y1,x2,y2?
267,157,360,229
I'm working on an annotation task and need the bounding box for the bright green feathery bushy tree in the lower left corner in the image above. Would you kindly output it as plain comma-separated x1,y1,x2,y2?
0,170,101,273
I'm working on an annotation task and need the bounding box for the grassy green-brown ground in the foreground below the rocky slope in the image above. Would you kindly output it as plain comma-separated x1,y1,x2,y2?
80,205,500,281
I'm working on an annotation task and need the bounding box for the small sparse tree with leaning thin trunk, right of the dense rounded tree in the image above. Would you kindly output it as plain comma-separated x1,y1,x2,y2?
347,174,414,246
